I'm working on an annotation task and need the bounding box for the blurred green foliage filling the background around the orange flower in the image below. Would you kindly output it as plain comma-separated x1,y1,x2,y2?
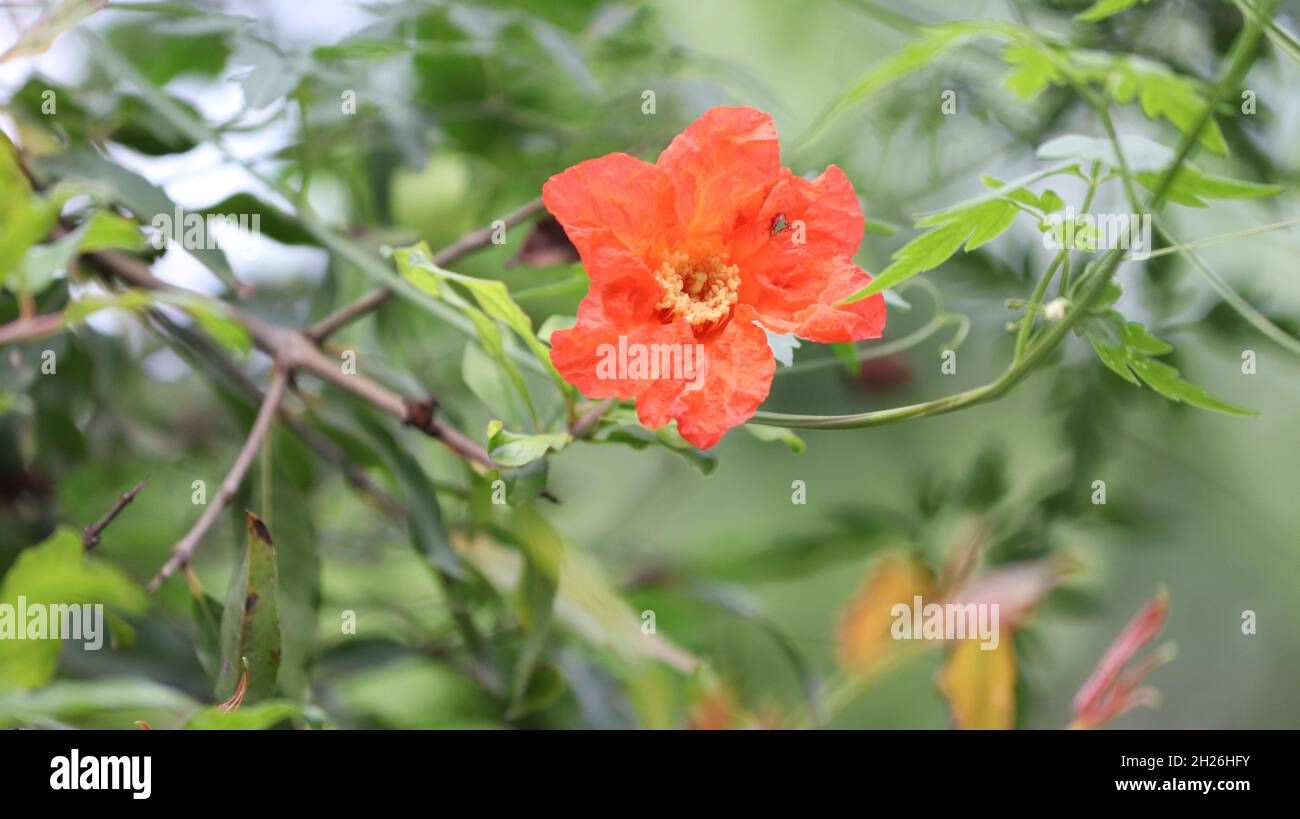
0,0,1300,728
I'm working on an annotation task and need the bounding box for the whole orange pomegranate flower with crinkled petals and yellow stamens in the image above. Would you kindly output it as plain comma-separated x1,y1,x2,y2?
542,108,885,449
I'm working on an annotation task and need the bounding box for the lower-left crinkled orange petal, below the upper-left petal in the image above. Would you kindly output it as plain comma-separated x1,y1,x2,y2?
551,278,696,400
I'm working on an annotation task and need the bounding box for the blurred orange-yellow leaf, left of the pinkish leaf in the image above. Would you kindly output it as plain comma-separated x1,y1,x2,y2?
836,555,933,673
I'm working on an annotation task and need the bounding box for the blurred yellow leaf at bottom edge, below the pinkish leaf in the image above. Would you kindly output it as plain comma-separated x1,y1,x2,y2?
939,636,1015,731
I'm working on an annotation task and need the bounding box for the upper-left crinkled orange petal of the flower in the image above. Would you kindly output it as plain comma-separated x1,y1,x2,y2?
542,153,681,288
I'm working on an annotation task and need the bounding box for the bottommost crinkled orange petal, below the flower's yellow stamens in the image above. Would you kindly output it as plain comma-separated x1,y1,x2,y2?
637,304,776,450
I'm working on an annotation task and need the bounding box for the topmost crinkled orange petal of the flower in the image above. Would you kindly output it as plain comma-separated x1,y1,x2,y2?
658,107,781,237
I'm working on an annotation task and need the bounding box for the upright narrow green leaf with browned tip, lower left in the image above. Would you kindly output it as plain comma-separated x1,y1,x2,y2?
216,512,280,703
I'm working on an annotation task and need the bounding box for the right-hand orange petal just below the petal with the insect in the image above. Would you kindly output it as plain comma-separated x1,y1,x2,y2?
740,256,885,343
